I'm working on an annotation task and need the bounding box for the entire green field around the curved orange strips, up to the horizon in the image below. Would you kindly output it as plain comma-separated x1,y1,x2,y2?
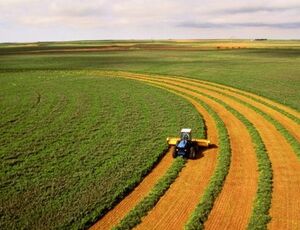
0,40,300,229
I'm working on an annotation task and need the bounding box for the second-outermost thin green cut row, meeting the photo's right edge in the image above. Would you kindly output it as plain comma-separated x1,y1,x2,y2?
183,80,300,158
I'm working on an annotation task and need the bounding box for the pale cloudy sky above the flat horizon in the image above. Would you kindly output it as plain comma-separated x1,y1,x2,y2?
0,0,300,42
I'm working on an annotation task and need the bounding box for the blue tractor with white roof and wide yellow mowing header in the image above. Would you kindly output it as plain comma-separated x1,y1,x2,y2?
167,128,210,159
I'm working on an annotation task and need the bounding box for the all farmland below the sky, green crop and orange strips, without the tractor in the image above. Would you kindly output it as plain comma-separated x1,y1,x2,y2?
0,40,300,229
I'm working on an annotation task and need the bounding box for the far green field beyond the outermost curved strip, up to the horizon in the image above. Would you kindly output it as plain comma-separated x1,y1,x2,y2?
0,40,300,111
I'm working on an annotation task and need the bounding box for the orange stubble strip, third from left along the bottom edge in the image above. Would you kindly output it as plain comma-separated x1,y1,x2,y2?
189,97,258,229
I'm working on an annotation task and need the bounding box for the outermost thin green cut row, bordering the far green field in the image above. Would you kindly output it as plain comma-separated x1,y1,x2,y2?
184,78,300,124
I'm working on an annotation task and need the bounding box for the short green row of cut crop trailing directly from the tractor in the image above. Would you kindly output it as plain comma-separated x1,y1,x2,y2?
113,157,186,230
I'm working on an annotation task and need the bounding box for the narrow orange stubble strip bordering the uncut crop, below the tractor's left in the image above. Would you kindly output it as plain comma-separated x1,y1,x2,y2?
90,149,173,230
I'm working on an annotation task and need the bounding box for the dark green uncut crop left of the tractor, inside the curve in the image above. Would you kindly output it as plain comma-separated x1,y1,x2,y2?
0,71,201,229
